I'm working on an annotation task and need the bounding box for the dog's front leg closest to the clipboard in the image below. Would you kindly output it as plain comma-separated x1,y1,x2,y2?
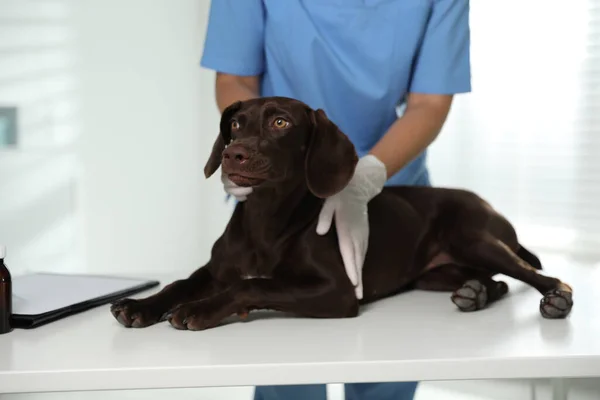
110,267,218,328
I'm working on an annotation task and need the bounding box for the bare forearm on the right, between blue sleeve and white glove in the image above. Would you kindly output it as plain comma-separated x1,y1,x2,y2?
370,95,452,177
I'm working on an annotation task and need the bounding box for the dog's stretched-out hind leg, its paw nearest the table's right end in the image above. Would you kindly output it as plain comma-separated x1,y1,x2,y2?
451,235,573,318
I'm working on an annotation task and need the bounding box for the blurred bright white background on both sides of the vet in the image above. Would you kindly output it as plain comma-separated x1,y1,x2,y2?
0,0,600,400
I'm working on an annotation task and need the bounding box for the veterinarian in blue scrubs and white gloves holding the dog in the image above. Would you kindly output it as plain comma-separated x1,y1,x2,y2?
201,0,471,400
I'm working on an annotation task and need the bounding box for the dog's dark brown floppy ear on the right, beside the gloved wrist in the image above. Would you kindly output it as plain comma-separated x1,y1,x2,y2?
305,109,358,198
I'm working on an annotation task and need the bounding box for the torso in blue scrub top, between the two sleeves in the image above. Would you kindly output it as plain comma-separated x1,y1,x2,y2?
261,0,431,184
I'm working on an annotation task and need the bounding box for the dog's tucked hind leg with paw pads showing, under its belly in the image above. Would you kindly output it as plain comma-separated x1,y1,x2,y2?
415,264,508,311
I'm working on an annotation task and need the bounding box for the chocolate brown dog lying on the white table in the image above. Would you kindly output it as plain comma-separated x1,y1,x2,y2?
111,97,573,330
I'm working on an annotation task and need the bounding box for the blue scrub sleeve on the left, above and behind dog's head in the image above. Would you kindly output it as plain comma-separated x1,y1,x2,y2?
200,0,265,76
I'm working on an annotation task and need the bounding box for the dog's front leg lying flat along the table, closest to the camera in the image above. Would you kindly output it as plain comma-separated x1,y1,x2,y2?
166,279,358,330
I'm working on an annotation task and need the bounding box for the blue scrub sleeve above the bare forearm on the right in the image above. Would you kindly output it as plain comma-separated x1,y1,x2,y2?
409,0,471,94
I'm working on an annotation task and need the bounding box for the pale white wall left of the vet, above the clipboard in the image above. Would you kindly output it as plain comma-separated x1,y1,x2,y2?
0,0,231,280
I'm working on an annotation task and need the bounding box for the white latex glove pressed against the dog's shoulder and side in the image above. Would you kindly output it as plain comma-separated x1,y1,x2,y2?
317,155,387,299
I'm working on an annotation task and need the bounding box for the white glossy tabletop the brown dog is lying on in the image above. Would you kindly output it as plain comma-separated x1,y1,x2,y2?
0,253,600,393
